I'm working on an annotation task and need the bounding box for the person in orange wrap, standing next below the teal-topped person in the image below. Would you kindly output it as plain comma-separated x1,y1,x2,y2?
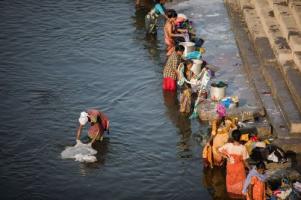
164,10,185,56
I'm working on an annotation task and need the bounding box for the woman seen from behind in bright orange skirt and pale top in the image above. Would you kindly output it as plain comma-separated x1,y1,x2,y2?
219,130,249,198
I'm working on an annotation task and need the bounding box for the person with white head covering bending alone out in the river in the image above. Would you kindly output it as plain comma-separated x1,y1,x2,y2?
76,109,110,144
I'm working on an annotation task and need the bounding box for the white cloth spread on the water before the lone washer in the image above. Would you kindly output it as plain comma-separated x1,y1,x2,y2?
61,142,97,162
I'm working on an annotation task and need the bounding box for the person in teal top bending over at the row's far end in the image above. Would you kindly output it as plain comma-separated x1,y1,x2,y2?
145,0,168,35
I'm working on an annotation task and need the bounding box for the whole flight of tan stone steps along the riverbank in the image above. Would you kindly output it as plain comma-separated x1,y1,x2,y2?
225,0,301,152
